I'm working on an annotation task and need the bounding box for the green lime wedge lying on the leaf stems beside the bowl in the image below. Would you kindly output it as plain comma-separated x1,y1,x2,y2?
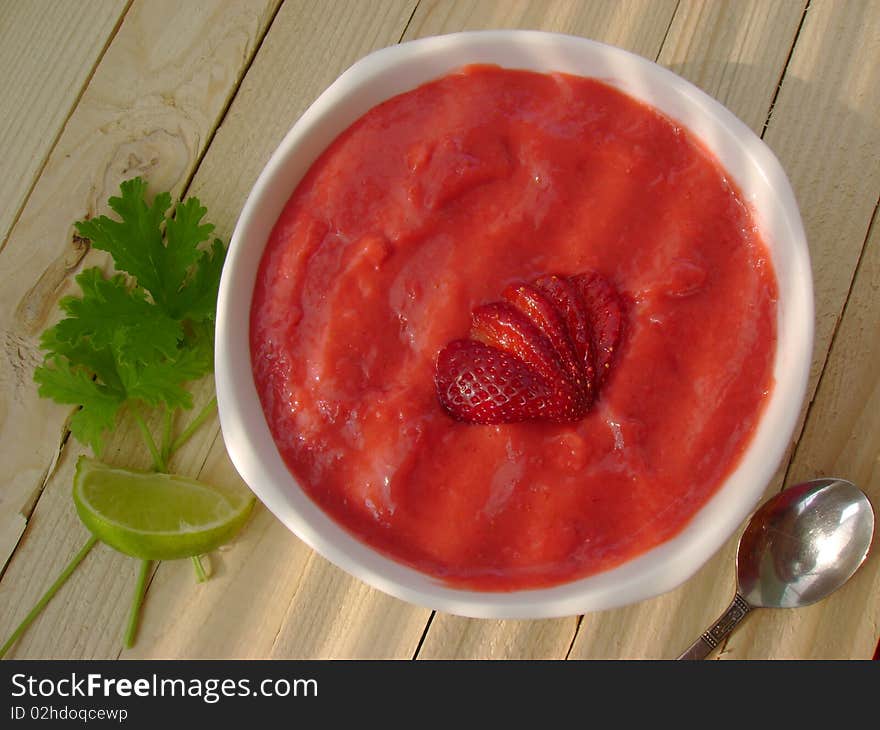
73,456,254,560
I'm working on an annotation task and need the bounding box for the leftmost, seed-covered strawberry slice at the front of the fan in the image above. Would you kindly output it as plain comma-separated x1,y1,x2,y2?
435,340,586,424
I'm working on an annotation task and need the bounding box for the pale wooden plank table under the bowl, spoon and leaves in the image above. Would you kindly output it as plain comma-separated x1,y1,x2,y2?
0,0,880,659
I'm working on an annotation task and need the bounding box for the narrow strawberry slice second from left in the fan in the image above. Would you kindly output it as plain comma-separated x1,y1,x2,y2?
471,302,568,381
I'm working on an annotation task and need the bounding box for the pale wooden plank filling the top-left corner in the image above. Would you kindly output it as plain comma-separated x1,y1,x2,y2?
0,0,128,249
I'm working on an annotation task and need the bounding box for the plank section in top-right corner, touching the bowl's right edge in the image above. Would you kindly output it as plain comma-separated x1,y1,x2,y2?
764,0,880,394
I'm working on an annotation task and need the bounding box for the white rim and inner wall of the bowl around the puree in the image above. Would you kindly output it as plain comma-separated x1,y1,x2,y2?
215,30,814,619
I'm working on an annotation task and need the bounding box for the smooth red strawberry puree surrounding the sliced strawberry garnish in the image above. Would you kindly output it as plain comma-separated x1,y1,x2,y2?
251,66,776,590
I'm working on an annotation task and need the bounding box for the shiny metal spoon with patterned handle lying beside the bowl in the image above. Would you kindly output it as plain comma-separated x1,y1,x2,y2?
678,479,874,659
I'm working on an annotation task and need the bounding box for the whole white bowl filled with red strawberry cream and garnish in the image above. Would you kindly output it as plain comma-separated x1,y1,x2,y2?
216,31,813,618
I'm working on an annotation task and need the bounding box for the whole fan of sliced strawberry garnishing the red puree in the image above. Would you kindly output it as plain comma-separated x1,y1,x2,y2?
434,272,625,424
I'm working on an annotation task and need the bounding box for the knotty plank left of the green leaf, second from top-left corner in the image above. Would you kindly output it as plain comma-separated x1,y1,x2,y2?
0,0,275,565
